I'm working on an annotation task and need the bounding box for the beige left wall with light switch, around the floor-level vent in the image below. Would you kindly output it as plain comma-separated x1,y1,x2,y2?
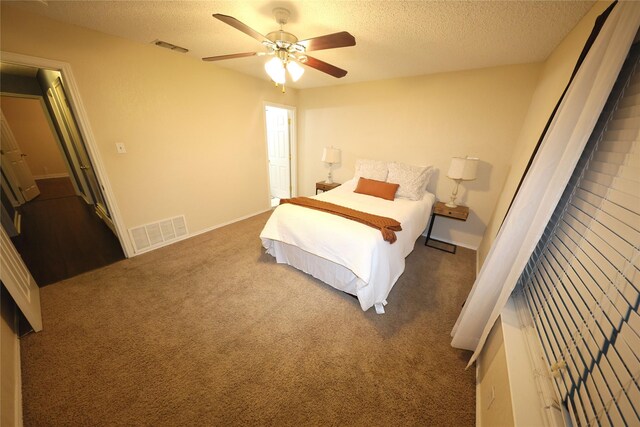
0,2,296,254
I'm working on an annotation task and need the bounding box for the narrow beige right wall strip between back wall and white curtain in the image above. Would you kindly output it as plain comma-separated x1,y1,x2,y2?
478,1,611,269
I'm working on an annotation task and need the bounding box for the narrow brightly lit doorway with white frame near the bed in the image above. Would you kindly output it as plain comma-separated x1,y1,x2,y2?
265,104,297,207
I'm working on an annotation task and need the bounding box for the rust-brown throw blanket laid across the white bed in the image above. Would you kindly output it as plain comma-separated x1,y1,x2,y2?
280,197,402,243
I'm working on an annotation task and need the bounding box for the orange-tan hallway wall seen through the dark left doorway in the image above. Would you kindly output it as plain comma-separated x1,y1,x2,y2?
0,96,69,179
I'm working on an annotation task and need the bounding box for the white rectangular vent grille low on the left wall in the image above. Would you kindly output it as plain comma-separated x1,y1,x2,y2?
129,215,188,254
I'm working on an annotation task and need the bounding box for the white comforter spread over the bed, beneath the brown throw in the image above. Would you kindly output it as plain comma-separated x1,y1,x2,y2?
260,179,434,310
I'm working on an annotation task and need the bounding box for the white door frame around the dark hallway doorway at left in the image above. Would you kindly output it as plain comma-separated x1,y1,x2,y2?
0,51,134,258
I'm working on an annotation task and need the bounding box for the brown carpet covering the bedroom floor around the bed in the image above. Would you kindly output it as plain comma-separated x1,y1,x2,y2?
21,214,475,426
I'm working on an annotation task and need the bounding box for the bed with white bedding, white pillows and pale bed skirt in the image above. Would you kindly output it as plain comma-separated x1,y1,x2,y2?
260,160,435,314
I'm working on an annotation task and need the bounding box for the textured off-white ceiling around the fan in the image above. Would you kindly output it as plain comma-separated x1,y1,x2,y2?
12,0,594,88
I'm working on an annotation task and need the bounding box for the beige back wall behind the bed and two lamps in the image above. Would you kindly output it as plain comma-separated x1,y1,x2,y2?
298,64,540,248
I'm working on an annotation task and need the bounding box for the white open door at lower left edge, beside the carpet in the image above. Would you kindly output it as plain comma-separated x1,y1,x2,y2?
0,227,42,332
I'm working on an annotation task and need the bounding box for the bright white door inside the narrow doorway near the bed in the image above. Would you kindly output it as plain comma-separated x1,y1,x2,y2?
265,106,291,199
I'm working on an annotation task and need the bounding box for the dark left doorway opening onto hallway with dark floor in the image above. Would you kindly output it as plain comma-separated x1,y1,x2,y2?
0,63,125,286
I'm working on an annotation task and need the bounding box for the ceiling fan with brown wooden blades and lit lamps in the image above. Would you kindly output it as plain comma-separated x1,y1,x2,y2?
202,7,356,89
